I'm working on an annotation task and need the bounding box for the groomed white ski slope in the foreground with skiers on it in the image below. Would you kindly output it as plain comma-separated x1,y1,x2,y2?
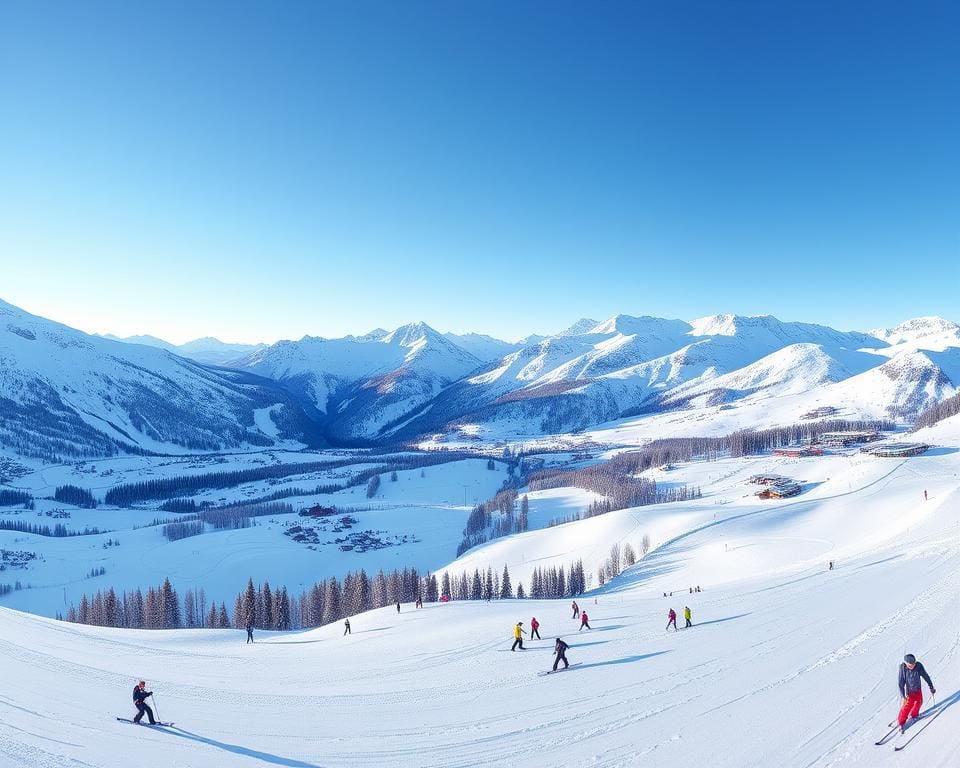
0,418,960,768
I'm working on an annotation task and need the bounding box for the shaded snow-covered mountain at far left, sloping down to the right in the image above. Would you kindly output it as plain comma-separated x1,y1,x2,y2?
0,302,317,457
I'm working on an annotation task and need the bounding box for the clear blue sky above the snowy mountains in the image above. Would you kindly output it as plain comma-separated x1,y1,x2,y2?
0,0,960,342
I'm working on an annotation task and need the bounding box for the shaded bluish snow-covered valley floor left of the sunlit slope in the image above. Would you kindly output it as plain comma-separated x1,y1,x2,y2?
0,452,510,616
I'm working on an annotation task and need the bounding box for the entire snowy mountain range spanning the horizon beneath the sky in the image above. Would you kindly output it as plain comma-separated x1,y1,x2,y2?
0,302,960,456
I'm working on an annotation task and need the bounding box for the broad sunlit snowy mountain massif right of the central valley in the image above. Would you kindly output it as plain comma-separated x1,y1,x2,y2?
384,314,916,444
